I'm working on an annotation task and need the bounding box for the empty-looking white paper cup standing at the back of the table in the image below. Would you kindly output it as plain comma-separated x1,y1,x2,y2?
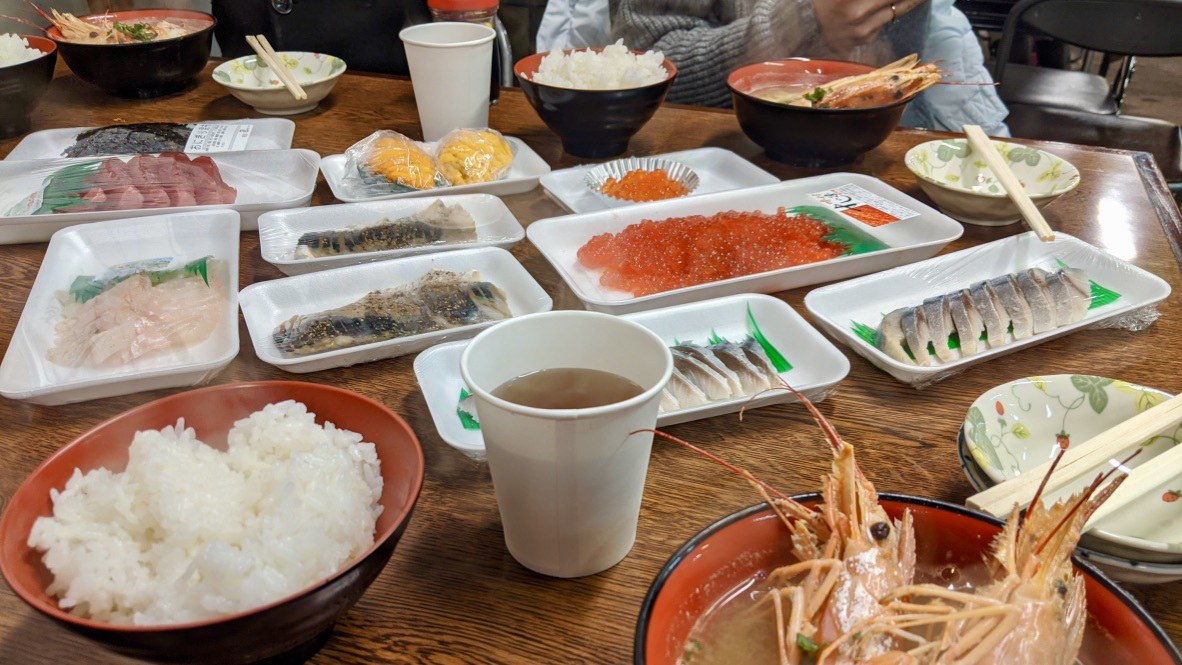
398,22,496,141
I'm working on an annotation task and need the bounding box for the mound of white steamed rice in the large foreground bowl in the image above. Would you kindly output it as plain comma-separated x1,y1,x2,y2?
28,400,382,625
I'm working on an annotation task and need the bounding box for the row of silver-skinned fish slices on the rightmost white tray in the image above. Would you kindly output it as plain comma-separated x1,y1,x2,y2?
875,268,1092,367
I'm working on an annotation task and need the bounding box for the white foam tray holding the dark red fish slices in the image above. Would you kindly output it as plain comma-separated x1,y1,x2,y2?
0,150,320,245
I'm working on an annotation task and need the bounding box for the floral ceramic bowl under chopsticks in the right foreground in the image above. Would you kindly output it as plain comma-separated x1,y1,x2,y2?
963,374,1182,562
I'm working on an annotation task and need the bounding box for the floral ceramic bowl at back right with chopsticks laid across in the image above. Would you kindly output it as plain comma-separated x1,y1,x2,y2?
903,138,1079,226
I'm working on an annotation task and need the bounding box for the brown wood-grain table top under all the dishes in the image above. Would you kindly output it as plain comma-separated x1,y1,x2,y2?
0,63,1182,664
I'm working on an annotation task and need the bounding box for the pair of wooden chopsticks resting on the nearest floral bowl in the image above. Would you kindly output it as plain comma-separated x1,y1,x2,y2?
965,395,1182,527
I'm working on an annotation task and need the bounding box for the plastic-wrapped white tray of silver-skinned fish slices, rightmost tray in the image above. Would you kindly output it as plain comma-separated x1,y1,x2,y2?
805,233,1170,387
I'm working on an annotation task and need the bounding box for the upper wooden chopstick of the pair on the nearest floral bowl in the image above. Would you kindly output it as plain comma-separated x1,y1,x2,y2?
965,395,1182,517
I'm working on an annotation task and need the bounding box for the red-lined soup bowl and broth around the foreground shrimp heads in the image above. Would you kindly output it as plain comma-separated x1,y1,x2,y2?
634,494,1182,665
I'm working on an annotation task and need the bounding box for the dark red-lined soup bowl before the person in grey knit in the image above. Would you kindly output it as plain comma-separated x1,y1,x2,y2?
727,58,911,168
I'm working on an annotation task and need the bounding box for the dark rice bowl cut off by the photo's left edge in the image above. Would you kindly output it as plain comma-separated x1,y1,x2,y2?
0,33,58,138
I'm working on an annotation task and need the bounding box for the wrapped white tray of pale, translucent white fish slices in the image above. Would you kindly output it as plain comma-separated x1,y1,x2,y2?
0,210,240,404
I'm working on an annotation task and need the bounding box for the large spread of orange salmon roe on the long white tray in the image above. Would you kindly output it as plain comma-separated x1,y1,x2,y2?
578,208,849,295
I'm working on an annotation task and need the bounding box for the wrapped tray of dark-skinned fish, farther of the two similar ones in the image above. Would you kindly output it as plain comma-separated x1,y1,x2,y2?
259,194,525,275
